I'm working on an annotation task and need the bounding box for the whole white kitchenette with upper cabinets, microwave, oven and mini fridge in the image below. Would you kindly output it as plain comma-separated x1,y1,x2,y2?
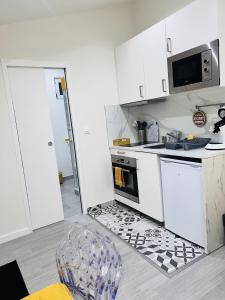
88,0,225,273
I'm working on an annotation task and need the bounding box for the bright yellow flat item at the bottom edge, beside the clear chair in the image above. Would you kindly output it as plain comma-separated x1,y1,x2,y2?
22,283,74,300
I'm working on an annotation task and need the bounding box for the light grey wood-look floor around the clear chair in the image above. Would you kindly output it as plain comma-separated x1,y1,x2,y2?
0,215,225,300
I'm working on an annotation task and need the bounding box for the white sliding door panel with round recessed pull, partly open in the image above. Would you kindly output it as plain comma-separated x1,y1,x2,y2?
8,67,64,229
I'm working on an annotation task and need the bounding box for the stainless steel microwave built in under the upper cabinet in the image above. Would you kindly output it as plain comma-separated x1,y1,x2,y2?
168,40,220,94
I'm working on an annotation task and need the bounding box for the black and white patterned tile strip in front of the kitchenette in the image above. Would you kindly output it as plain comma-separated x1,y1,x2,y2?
88,201,204,274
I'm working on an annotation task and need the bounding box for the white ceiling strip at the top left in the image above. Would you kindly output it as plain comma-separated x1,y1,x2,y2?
0,0,132,25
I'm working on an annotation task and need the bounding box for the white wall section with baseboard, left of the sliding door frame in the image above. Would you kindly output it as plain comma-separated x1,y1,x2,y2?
0,63,29,243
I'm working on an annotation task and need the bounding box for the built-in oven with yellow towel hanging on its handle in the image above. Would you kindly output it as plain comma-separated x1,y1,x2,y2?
111,155,139,203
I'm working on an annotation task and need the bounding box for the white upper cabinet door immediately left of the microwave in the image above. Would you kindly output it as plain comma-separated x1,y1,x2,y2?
142,21,169,99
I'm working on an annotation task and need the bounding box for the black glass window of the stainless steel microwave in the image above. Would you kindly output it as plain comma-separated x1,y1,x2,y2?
173,53,202,87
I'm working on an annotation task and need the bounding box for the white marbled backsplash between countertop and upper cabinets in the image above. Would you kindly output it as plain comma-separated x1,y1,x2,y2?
105,88,225,145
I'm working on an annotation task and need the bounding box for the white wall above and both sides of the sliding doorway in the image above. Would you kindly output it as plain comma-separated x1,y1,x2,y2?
0,5,133,241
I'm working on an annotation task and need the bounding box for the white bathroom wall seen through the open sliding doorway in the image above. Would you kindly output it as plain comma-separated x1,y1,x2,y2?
45,69,73,177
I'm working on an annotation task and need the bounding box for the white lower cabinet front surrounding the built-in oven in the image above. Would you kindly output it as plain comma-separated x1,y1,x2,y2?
111,149,164,222
